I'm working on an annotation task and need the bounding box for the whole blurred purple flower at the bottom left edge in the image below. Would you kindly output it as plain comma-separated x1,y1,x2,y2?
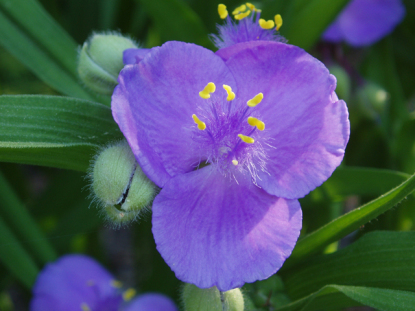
30,255,177,311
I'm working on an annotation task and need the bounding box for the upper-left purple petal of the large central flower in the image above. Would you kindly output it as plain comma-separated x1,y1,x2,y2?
112,42,236,186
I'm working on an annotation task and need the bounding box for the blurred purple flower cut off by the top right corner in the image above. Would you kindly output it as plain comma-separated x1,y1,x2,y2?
323,0,405,47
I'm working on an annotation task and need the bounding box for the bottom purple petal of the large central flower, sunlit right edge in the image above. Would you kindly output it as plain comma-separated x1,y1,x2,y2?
153,165,302,291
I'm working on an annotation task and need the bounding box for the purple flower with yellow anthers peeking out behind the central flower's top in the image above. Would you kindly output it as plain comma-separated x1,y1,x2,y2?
210,2,286,49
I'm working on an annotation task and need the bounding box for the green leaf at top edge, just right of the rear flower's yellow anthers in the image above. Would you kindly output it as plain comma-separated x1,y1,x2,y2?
286,0,349,50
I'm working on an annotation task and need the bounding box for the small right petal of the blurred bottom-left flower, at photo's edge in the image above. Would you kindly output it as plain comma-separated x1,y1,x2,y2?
123,293,178,311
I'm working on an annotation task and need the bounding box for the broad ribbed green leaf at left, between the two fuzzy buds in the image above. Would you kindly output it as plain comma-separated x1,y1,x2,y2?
0,95,122,171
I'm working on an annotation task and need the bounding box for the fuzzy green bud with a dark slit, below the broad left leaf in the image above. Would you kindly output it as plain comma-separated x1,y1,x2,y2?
90,140,156,227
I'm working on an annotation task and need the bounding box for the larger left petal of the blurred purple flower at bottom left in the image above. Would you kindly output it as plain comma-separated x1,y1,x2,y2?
30,255,122,311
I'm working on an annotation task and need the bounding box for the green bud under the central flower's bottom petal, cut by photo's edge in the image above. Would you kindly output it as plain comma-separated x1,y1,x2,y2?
182,284,244,311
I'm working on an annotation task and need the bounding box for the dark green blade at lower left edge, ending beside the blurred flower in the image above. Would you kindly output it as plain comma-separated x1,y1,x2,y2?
0,217,39,289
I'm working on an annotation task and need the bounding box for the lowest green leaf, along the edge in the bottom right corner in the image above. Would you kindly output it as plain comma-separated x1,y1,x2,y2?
275,285,415,311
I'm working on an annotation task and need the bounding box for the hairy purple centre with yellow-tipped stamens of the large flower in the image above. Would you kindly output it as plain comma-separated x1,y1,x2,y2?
192,82,265,177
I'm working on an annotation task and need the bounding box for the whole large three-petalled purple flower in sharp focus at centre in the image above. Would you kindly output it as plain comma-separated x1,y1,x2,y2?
112,41,349,291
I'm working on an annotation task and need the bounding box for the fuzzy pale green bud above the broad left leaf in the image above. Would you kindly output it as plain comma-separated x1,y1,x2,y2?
78,33,137,95
